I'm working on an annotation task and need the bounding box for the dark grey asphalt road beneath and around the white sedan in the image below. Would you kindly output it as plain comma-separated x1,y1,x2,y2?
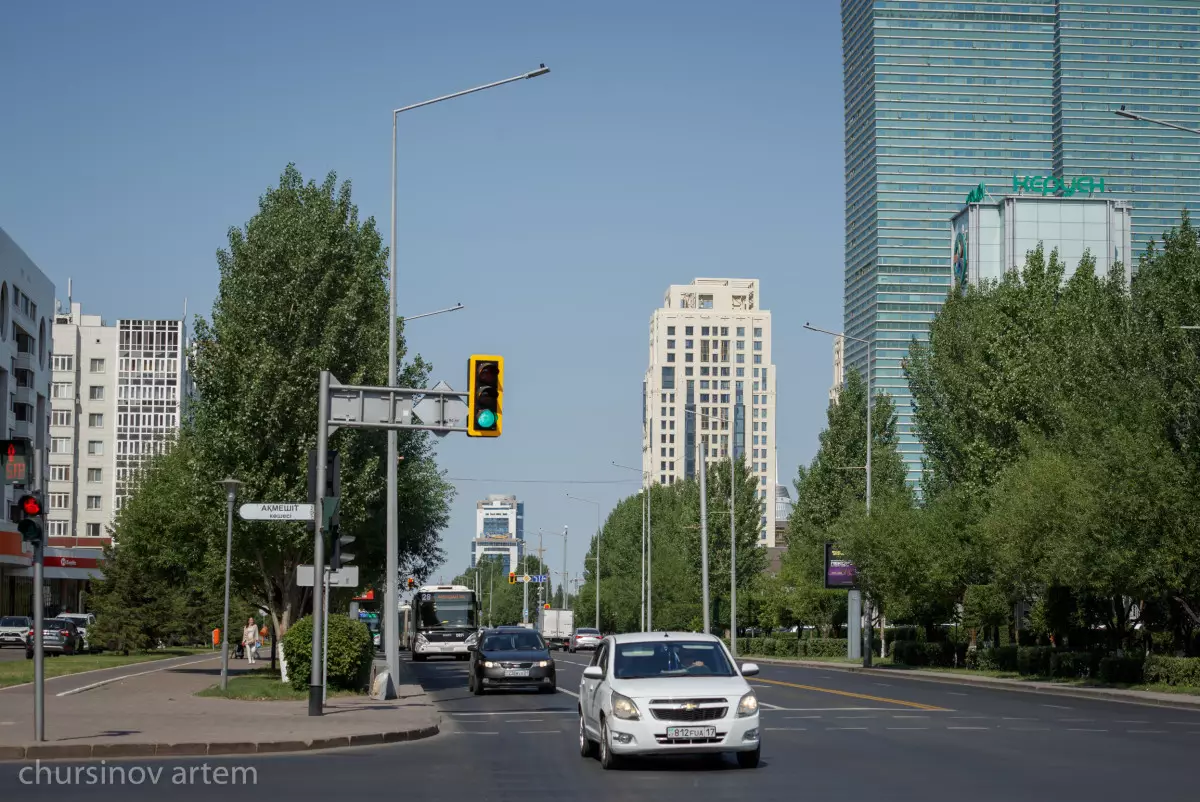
0,654,1200,802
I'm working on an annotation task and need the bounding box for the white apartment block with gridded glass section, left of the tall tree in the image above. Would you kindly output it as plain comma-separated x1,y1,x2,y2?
47,297,191,549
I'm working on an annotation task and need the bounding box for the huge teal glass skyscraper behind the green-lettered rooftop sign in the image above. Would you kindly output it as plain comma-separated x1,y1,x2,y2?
841,0,1200,481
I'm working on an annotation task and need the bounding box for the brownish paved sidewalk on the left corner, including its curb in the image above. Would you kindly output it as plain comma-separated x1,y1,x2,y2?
0,657,440,760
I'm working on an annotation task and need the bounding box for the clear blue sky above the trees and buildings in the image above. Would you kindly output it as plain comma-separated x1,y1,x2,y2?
0,0,844,579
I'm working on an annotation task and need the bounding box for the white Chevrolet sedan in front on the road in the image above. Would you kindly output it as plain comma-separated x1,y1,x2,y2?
580,633,762,768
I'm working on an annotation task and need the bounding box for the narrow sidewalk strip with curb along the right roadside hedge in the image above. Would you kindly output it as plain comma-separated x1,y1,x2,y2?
745,657,1200,710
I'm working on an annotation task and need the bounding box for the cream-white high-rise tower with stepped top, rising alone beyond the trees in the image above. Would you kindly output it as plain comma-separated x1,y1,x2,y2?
642,279,775,546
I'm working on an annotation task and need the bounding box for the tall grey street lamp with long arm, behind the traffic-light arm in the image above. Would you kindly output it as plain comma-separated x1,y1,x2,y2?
383,64,550,686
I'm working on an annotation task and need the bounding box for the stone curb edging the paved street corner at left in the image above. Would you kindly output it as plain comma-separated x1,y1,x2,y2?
0,723,442,760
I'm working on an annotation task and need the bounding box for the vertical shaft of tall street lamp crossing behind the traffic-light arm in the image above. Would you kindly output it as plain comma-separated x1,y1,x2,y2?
386,112,400,698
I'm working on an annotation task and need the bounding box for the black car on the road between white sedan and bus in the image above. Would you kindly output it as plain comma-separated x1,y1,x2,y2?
467,627,558,696
